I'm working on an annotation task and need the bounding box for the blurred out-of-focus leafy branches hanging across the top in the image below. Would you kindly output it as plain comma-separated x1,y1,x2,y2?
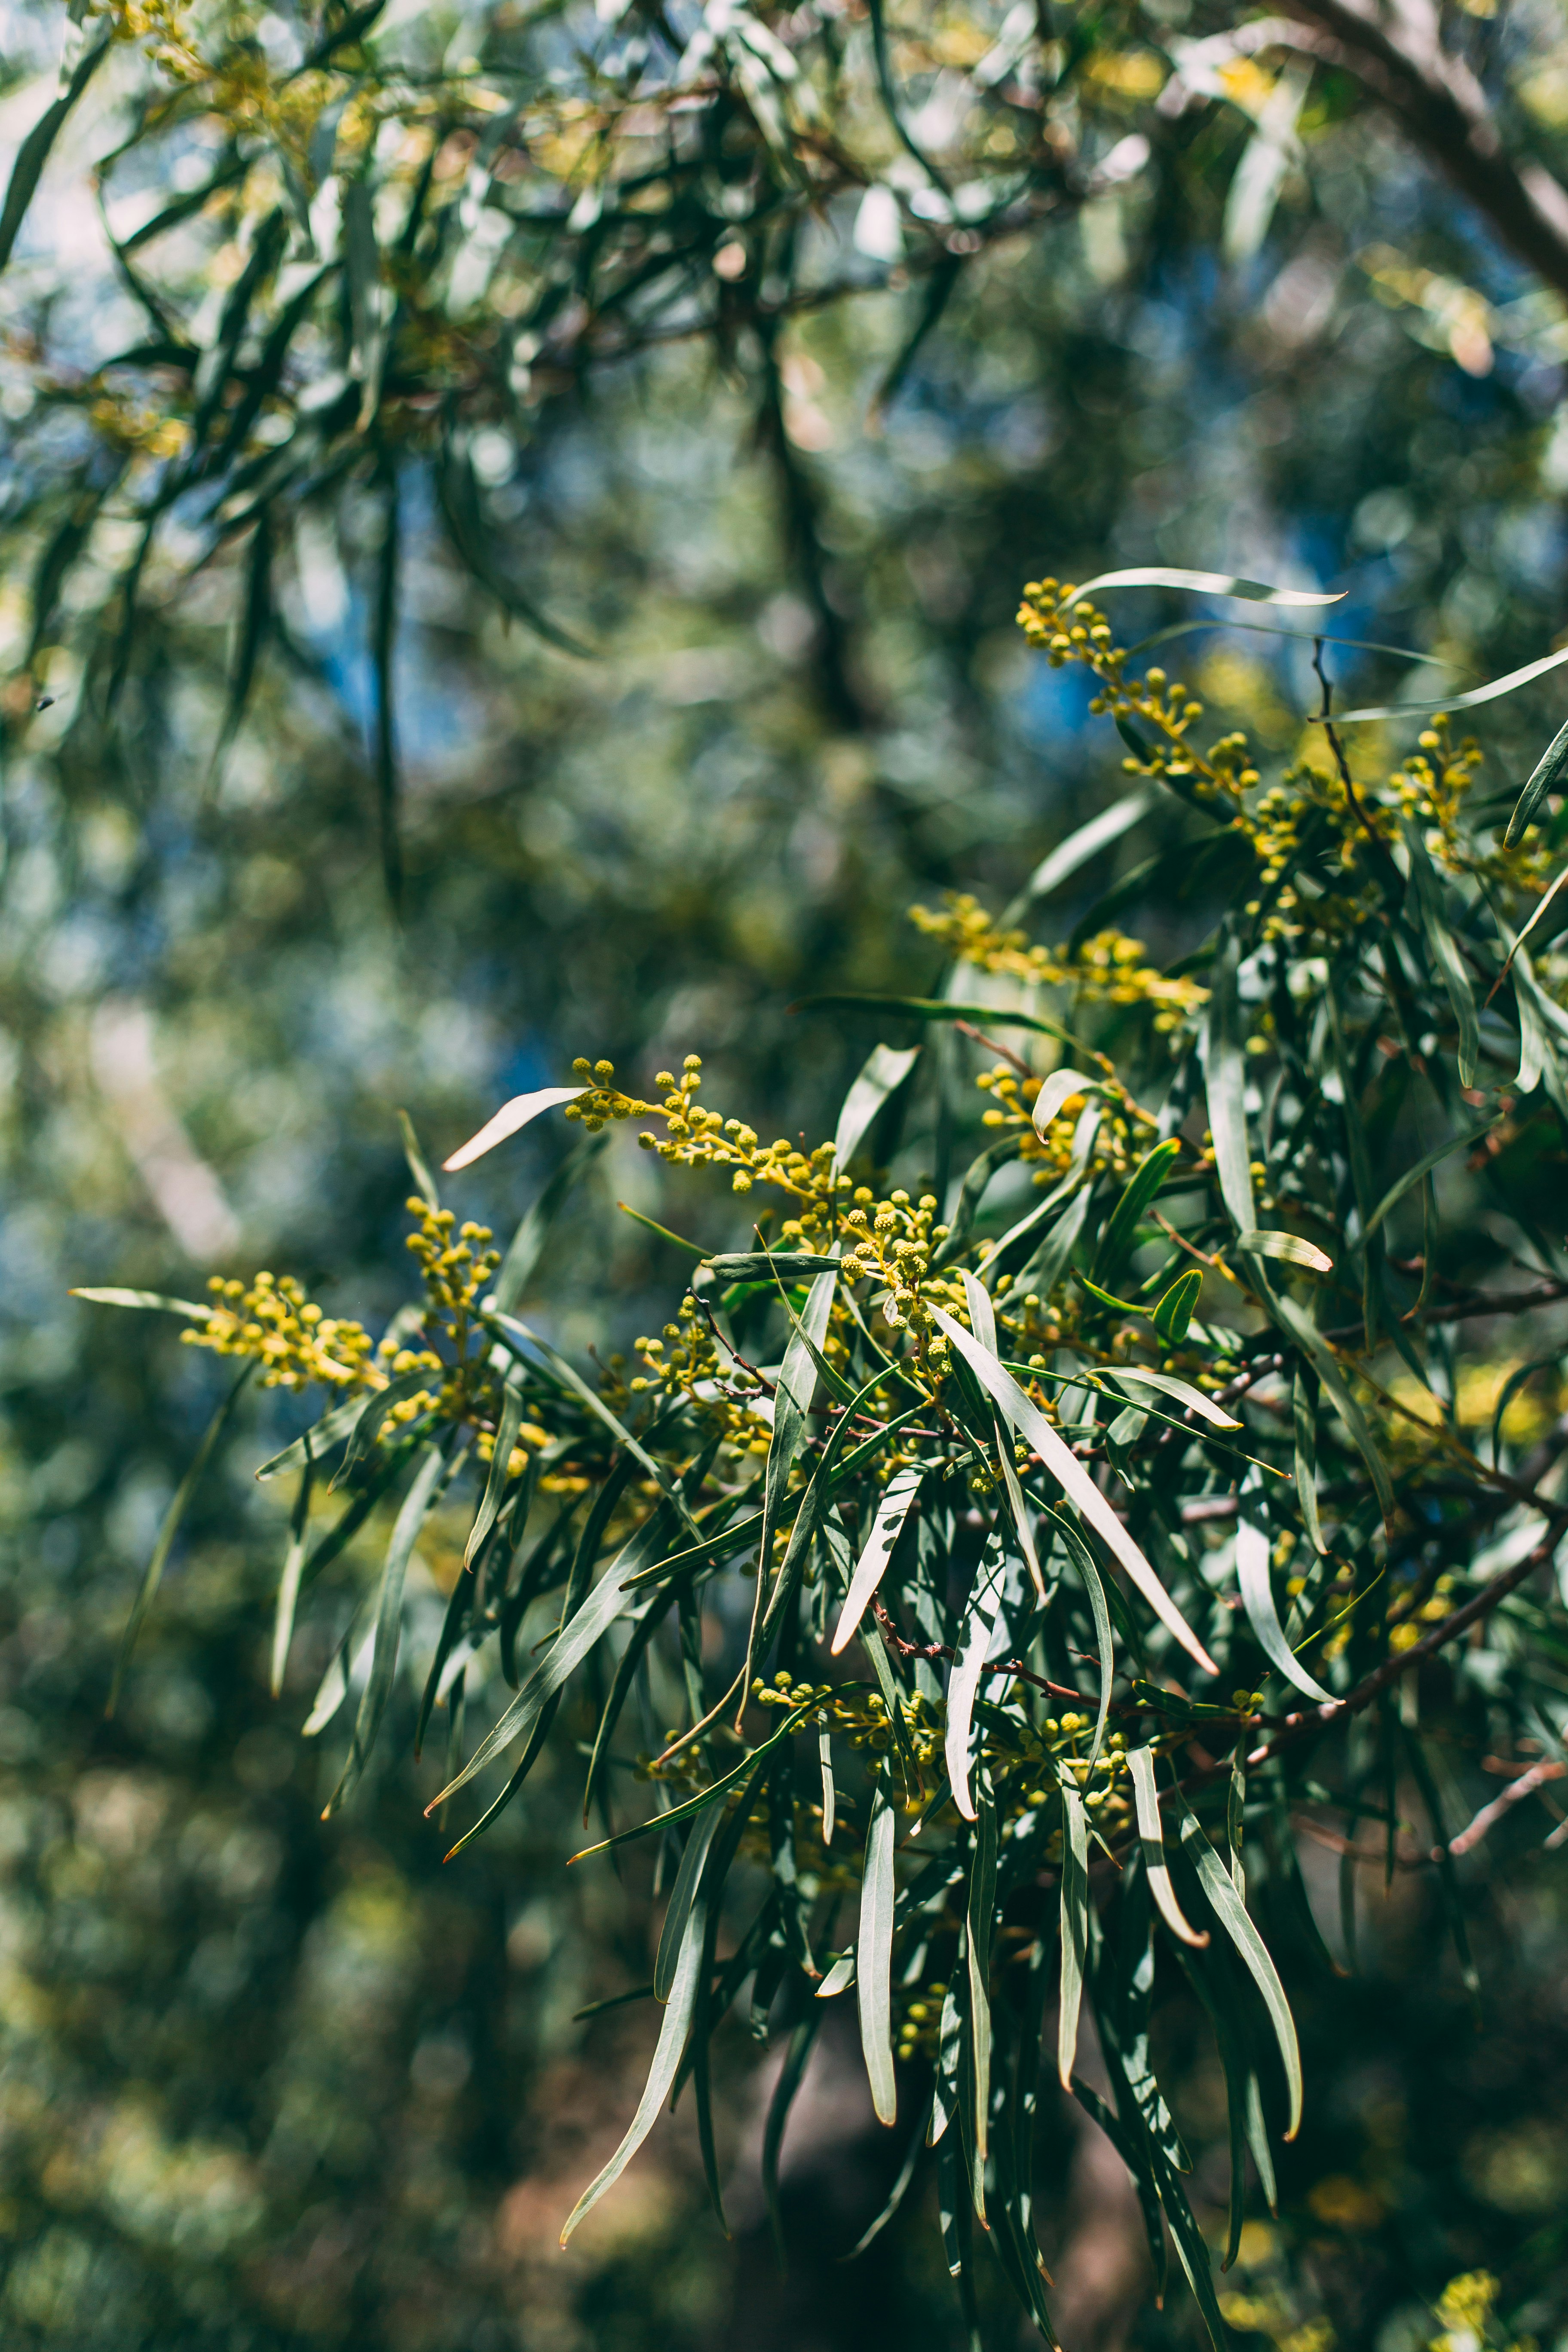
0,0,1568,889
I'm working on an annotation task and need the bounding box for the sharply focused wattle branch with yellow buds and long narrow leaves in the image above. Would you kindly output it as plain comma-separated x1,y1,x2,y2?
96,572,1568,2343
